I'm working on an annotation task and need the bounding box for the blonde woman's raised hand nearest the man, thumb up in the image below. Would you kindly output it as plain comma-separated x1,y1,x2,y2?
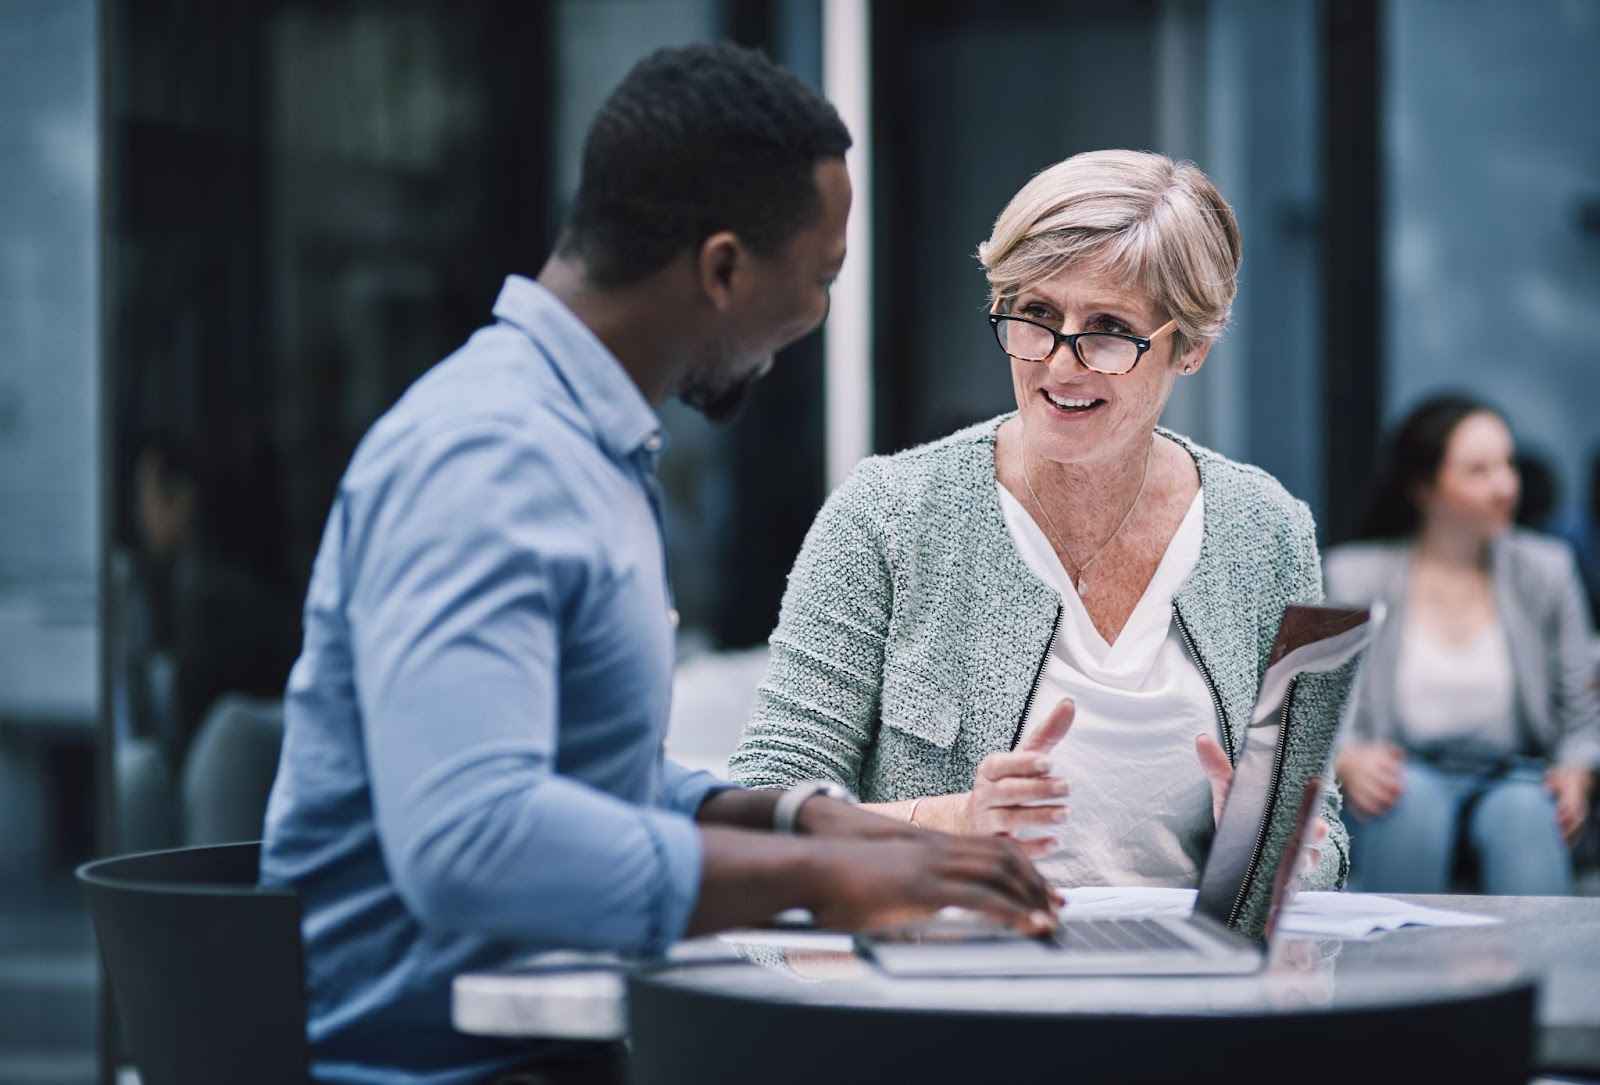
955,698,1075,858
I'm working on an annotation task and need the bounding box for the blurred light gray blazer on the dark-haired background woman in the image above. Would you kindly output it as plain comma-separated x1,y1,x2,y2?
1326,531,1600,765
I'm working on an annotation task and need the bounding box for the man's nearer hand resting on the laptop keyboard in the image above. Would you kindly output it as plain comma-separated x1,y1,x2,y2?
811,831,1056,935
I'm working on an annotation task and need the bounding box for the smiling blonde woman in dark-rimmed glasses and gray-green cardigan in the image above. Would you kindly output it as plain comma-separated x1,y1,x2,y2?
730,150,1347,887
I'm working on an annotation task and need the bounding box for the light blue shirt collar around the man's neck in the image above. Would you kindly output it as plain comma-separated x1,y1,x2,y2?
494,275,662,459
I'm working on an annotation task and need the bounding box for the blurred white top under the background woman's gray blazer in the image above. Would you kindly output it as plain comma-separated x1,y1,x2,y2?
1395,618,1517,754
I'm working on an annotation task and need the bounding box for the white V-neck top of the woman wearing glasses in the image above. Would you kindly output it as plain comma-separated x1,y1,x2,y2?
997,483,1218,887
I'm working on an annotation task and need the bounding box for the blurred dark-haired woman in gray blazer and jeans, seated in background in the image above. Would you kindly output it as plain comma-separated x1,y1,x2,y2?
1328,395,1600,895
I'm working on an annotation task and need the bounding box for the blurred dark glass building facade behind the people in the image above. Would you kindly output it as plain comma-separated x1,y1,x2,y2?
0,0,1600,1082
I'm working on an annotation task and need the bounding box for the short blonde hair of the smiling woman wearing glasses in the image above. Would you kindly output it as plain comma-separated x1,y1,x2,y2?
978,150,1240,357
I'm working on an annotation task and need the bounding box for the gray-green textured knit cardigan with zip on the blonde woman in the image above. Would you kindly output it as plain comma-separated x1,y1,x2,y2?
730,414,1354,922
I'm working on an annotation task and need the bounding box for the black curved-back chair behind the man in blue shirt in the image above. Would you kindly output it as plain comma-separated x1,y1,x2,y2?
77,842,310,1085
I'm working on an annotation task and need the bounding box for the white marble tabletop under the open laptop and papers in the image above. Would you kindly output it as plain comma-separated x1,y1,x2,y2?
453,896,1600,1074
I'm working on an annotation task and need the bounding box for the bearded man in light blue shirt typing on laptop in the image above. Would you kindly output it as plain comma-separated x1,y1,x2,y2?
262,38,1051,1082
